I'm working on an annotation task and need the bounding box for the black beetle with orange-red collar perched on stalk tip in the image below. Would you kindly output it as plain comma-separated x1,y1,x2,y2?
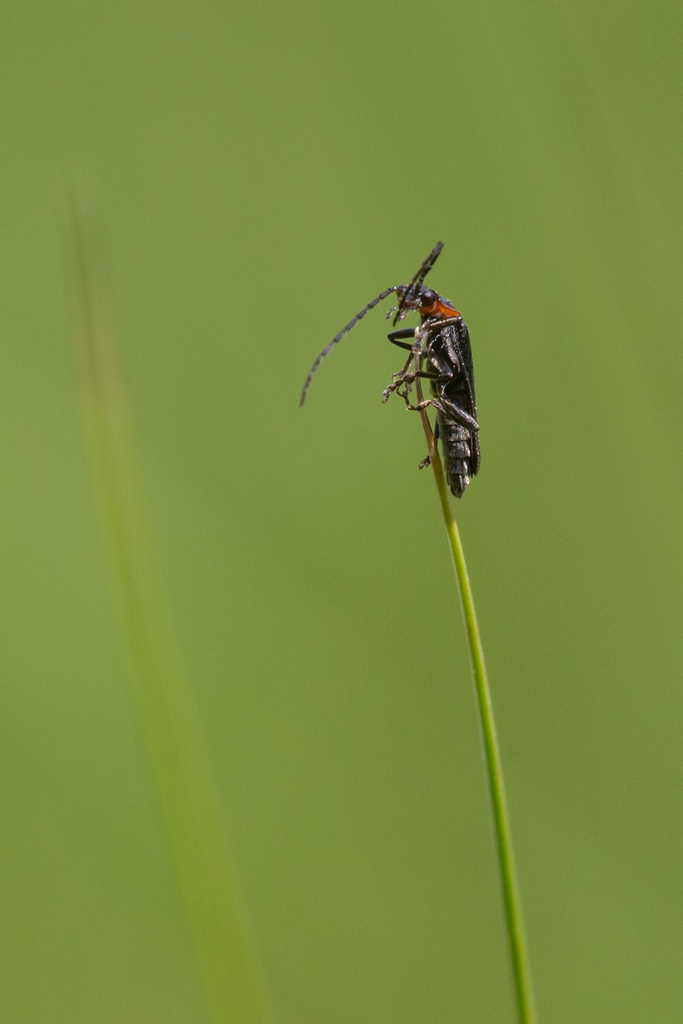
300,242,481,498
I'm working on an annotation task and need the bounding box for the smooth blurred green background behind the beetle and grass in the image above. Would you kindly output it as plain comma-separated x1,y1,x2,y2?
0,0,683,1024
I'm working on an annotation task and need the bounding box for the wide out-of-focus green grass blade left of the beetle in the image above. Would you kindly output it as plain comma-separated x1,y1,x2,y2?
68,186,272,1024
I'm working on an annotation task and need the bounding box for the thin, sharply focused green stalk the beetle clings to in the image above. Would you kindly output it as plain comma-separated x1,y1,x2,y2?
415,354,537,1024
